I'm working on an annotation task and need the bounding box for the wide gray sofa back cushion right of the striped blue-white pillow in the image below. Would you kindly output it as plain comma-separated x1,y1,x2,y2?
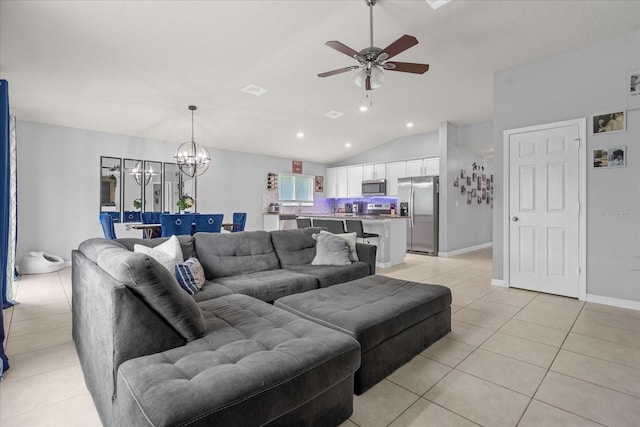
194,231,280,280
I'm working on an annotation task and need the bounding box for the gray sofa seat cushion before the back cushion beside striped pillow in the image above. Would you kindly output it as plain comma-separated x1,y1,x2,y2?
214,269,318,302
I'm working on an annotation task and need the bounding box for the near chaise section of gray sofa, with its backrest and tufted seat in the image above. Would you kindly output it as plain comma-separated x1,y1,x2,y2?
72,239,360,426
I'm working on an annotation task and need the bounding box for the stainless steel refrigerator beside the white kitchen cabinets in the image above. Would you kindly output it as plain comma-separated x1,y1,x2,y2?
398,176,439,255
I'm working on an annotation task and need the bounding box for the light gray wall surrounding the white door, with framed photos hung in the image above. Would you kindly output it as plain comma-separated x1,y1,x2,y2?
493,31,640,302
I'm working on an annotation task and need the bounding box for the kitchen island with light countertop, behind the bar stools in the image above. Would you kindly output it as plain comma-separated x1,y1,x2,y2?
298,213,409,268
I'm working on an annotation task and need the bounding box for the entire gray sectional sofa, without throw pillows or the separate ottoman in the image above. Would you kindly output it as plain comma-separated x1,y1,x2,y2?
72,229,376,426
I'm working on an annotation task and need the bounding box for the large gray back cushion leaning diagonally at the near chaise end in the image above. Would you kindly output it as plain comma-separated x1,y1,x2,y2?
79,239,206,341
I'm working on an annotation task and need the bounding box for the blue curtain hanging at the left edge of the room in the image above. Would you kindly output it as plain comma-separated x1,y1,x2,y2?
0,80,15,379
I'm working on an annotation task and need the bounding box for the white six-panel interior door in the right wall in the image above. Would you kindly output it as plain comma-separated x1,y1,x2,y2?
508,124,581,297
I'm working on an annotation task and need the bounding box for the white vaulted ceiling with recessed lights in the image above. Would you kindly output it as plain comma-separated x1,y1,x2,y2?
0,0,640,163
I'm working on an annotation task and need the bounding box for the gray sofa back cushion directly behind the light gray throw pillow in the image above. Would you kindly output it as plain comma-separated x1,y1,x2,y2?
271,227,325,268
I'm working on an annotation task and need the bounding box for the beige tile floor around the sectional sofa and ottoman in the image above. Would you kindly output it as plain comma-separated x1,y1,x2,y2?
0,250,640,427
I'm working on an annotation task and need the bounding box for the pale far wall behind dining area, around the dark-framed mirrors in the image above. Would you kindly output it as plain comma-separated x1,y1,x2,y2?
16,120,326,262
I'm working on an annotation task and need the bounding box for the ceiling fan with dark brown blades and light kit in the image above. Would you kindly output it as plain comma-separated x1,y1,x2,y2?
318,0,429,90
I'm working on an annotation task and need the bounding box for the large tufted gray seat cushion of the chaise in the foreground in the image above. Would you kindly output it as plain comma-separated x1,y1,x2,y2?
118,295,360,426
